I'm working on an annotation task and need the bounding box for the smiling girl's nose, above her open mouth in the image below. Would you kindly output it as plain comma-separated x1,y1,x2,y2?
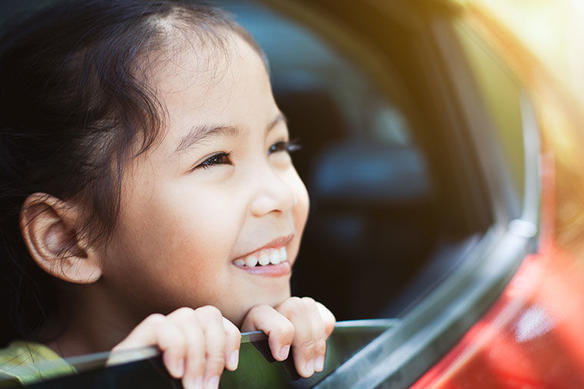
251,166,297,217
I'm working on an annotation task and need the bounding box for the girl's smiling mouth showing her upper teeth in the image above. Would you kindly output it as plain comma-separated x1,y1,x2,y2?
233,235,294,277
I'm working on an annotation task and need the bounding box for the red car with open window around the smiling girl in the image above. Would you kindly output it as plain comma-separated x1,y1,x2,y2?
0,0,584,389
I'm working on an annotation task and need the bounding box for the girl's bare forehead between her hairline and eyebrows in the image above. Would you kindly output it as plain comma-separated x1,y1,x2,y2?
137,27,277,153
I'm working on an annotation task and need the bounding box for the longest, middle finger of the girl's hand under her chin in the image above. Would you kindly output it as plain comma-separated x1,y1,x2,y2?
277,297,326,377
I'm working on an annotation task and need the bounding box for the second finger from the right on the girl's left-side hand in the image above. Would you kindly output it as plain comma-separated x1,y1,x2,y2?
195,306,226,389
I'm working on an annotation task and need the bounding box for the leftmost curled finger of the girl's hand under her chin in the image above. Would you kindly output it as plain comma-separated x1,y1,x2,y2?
241,305,294,361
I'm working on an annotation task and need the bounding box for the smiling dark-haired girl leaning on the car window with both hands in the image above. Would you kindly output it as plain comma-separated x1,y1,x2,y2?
0,0,335,388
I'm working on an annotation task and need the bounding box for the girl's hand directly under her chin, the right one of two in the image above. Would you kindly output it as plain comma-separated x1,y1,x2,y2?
241,297,335,377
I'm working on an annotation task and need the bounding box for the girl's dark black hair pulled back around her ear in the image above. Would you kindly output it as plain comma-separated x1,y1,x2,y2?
0,0,261,346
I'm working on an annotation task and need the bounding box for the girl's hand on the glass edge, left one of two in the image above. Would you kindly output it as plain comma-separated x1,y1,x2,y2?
112,306,241,389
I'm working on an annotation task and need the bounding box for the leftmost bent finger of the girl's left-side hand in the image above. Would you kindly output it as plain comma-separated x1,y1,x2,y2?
108,314,186,378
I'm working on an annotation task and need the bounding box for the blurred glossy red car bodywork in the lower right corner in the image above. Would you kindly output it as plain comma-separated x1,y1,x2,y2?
413,160,584,389
